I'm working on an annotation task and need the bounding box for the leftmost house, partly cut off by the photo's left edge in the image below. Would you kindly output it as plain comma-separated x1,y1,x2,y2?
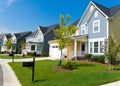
0,33,11,53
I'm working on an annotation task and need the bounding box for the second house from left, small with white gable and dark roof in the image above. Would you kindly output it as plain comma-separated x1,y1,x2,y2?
11,31,32,53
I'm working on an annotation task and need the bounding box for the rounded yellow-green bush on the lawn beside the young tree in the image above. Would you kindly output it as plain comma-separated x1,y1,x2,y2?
61,60,77,70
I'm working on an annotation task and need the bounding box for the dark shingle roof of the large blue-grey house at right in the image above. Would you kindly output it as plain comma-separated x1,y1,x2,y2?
92,1,120,17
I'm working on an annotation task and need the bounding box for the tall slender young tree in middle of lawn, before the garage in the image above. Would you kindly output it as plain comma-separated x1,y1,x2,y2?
54,15,76,66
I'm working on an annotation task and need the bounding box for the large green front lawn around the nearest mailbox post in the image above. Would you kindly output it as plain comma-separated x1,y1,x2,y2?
10,60,120,86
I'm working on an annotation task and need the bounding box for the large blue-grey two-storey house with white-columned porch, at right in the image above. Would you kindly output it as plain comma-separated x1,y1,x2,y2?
48,1,120,59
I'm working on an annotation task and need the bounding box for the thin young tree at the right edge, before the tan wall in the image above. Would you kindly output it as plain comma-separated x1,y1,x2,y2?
104,37,120,71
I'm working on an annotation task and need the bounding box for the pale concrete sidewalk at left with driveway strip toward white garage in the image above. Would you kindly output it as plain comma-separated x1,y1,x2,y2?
0,57,55,86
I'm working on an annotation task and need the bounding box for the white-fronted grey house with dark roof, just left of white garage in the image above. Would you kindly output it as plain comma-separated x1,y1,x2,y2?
25,24,59,55
